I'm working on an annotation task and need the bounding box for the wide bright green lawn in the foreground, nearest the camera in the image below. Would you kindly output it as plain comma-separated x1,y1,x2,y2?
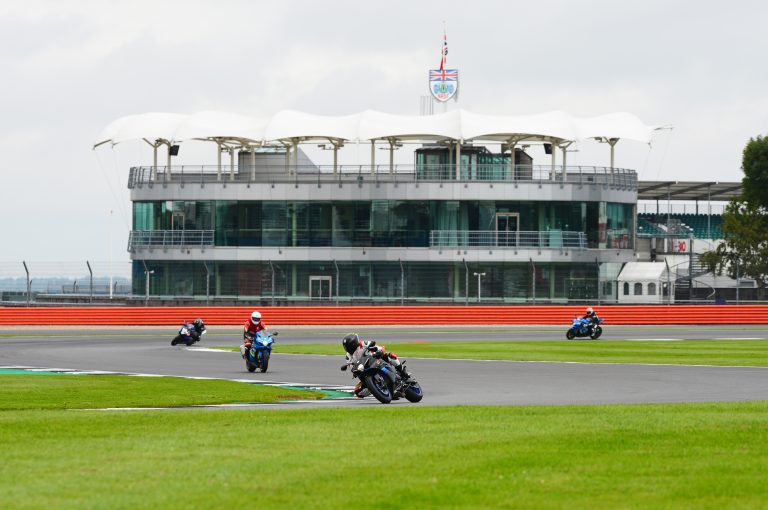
0,402,768,509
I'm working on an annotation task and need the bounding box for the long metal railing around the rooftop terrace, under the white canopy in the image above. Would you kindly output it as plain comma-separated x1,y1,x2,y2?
128,164,637,189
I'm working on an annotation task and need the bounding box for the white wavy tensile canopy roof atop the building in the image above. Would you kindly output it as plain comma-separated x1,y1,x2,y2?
94,110,659,147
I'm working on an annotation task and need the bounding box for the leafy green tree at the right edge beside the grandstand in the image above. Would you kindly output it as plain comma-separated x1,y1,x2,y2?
700,136,768,299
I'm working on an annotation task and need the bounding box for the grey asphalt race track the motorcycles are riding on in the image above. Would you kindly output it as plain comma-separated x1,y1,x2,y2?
0,326,768,407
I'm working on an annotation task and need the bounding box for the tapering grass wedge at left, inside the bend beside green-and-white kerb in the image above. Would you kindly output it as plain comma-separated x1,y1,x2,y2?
0,375,323,410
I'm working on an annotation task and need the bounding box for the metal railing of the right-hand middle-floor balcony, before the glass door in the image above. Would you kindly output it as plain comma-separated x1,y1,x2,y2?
429,230,587,250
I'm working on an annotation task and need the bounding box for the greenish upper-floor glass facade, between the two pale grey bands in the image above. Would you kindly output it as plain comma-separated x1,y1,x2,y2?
133,200,634,249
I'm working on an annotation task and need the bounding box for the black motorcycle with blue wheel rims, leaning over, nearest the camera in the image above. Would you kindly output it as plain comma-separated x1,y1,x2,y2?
341,352,424,404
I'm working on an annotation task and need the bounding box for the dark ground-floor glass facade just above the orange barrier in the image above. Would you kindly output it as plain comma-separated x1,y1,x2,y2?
133,260,600,303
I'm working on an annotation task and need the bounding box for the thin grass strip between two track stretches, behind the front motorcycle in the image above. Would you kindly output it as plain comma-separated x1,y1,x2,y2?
249,340,768,367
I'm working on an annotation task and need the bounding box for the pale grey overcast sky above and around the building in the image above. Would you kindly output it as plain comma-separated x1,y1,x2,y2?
0,0,768,270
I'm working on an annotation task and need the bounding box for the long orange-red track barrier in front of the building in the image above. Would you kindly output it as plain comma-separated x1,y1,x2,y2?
0,305,768,326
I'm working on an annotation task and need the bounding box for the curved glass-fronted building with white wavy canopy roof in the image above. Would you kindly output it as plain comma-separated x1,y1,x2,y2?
96,110,736,304
